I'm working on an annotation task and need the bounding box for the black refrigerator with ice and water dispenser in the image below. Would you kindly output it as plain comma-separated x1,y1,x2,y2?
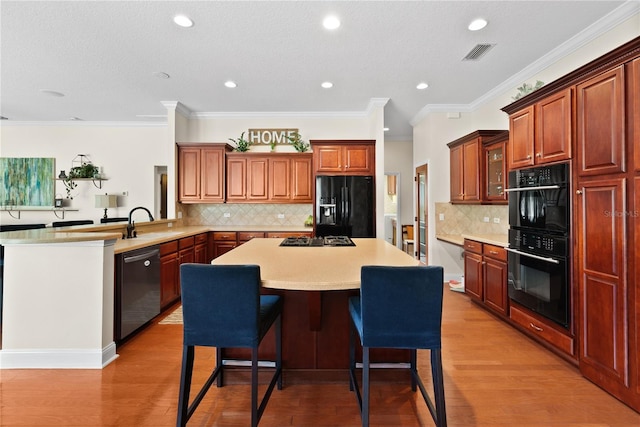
316,176,376,237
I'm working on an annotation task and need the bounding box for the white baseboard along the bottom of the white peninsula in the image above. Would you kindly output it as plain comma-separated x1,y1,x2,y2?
0,342,118,369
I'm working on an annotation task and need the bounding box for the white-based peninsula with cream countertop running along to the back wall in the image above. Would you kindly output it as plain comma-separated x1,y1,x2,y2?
0,220,306,369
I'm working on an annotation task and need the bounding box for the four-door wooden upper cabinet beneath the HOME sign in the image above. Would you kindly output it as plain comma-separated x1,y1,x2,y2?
227,152,313,203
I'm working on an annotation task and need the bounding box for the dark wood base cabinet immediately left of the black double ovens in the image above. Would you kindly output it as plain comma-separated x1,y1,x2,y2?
464,239,509,316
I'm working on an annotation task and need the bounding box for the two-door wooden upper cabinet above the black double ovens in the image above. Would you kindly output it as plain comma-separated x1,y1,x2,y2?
508,88,572,169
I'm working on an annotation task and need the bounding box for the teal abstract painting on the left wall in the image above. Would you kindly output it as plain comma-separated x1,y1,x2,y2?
0,157,55,206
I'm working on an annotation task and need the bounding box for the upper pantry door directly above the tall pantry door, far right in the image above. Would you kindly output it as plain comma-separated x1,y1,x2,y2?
576,66,625,176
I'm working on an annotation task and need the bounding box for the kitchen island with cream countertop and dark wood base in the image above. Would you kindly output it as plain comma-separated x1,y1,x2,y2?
211,239,418,381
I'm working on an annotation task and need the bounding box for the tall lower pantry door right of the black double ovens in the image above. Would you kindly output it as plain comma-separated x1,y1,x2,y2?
575,178,629,394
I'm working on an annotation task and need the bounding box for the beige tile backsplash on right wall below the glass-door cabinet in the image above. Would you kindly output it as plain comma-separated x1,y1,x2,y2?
435,203,509,235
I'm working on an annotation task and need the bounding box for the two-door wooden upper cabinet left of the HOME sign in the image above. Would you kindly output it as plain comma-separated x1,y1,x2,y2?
178,144,232,203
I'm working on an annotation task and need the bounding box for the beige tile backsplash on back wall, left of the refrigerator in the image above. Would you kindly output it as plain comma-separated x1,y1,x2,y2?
181,203,313,227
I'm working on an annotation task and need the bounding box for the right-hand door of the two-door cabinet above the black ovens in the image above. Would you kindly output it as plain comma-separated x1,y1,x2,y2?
535,89,571,164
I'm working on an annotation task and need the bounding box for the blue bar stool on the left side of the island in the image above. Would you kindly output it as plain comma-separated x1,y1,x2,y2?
177,264,283,427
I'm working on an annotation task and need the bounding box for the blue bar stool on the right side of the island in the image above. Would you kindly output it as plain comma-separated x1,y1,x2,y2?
349,266,447,427
